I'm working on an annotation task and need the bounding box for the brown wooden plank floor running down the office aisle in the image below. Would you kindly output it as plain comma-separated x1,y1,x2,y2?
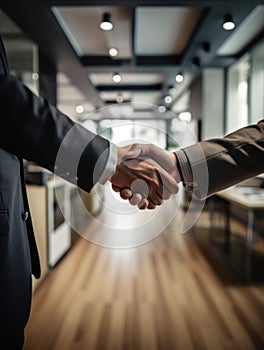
24,214,264,350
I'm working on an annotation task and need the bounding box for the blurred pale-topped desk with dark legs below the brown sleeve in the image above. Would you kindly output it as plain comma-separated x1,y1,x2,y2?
209,186,264,283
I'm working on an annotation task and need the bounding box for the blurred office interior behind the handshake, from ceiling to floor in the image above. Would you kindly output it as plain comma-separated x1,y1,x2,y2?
0,0,264,350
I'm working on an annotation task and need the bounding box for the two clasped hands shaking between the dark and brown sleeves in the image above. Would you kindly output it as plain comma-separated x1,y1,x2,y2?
110,144,181,209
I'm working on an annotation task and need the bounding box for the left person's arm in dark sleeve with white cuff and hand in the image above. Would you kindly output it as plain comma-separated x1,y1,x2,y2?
0,75,178,200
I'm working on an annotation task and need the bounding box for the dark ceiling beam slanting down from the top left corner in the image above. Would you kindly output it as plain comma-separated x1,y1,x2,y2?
1,1,102,106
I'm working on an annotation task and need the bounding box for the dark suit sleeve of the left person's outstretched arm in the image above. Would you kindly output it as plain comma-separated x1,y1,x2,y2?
0,75,109,192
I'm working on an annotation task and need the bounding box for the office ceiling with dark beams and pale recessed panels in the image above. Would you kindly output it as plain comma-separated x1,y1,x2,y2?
0,0,264,119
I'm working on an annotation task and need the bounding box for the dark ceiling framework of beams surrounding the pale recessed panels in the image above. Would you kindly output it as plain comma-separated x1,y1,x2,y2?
1,0,264,106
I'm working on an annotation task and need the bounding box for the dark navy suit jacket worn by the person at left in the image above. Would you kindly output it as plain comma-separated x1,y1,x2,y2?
0,38,109,340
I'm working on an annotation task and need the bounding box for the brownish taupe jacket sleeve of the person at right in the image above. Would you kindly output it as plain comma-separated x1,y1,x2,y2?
176,120,264,198
